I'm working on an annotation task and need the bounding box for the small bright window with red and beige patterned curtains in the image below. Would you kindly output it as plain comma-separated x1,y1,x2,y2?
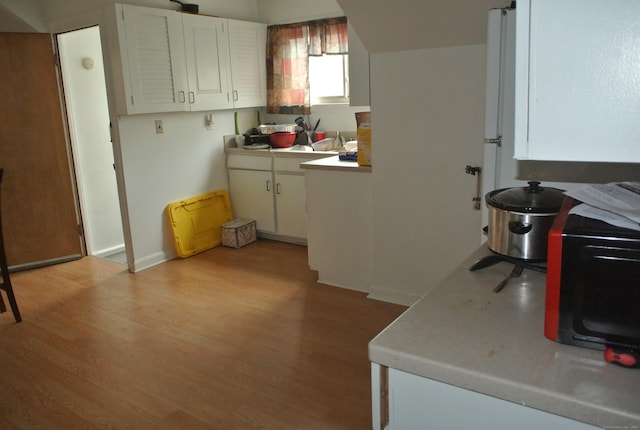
267,17,349,115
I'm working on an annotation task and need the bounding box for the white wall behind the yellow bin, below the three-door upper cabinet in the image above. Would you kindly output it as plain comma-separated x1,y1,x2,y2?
118,111,234,271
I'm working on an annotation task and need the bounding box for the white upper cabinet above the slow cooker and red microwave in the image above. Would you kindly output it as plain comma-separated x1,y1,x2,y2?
515,0,640,163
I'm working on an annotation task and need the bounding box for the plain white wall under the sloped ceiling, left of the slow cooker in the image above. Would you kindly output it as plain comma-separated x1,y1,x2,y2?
371,45,486,304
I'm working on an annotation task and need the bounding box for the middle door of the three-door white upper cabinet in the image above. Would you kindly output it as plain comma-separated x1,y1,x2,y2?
182,14,233,111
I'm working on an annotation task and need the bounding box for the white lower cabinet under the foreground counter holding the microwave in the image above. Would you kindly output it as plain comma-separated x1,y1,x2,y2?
371,363,598,430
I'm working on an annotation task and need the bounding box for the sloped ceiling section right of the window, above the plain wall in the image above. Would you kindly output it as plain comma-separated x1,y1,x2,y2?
337,0,511,54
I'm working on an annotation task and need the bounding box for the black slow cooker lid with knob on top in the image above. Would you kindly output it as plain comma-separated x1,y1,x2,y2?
485,181,565,213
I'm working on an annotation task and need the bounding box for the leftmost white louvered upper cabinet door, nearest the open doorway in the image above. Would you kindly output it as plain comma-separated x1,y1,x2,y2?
116,5,188,114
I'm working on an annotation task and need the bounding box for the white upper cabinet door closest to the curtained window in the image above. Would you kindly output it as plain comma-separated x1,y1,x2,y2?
228,19,267,108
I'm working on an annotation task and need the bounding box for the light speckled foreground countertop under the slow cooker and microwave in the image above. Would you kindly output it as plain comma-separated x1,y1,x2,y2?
369,245,640,429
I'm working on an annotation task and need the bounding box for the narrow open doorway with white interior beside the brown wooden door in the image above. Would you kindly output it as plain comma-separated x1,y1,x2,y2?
56,26,127,264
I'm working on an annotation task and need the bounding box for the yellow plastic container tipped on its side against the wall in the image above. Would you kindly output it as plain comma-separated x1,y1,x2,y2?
166,190,233,258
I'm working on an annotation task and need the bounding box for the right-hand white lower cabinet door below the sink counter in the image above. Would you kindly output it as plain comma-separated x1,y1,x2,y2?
274,173,307,239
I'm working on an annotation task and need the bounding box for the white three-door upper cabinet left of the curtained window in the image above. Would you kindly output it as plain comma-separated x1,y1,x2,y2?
106,4,267,114
